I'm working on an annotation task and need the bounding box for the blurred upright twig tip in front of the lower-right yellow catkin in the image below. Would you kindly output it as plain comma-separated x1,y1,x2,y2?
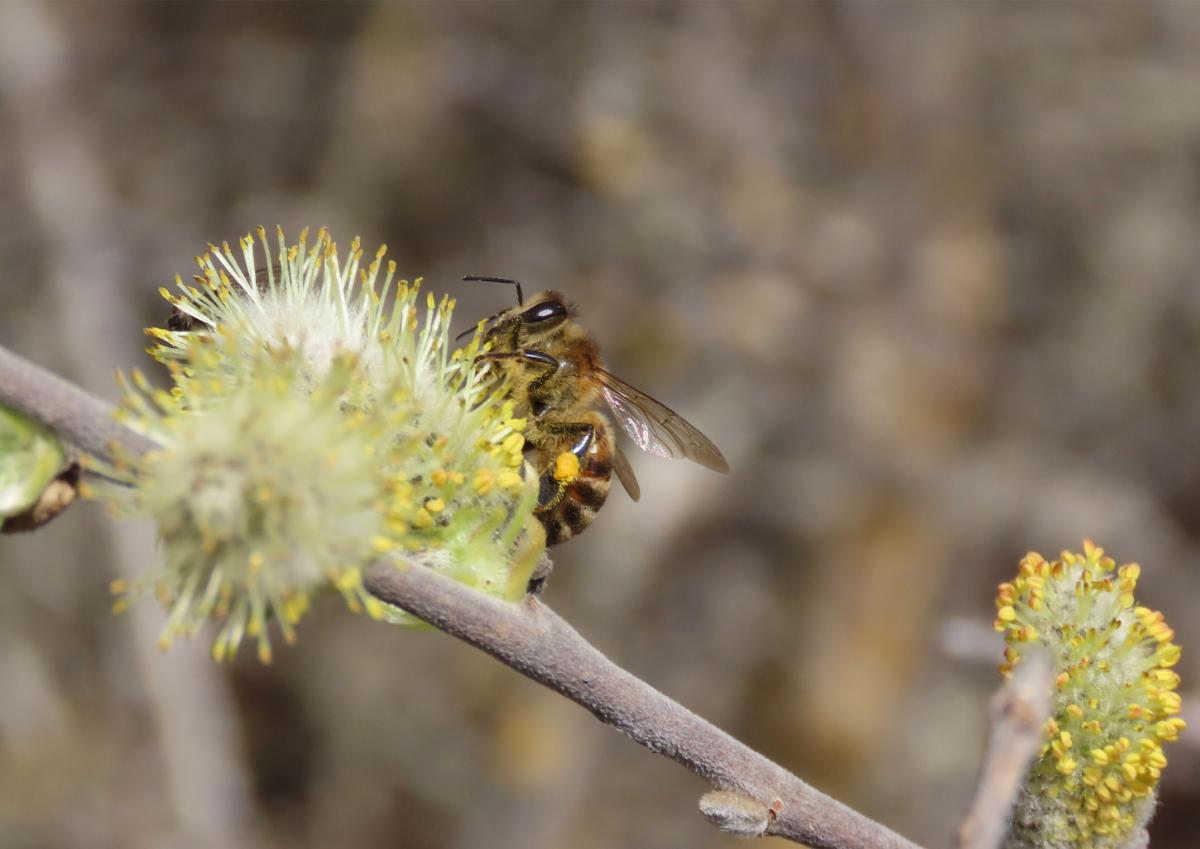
958,651,1054,849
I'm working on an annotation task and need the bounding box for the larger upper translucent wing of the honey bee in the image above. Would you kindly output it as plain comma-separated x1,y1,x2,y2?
593,367,730,470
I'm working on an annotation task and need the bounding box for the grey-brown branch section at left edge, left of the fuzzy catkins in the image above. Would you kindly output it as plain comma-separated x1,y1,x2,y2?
0,345,155,458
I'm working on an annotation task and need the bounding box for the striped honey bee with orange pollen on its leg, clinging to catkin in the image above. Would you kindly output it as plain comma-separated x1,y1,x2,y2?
463,277,730,546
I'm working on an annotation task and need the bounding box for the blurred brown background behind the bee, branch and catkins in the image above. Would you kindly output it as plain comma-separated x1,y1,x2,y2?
0,2,1200,849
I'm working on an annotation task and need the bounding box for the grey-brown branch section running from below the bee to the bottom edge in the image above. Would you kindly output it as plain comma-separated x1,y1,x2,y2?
365,564,917,849
